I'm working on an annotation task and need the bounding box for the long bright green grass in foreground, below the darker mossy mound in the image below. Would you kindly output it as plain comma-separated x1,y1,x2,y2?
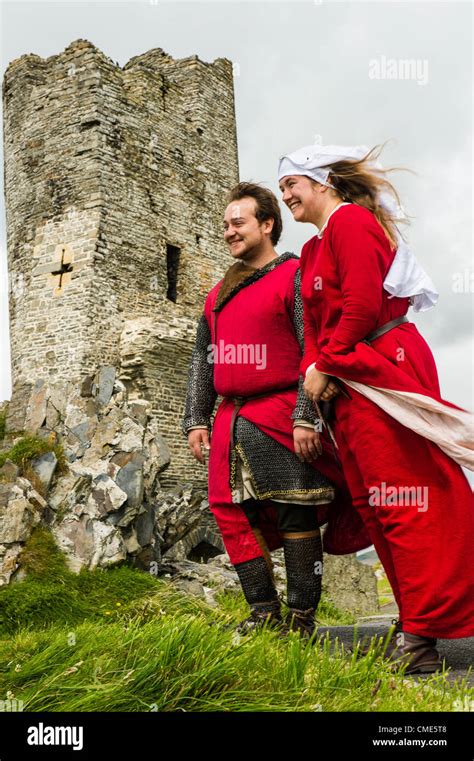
0,582,473,711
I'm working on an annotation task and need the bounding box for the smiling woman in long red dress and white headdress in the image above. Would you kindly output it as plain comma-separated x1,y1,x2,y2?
279,146,474,673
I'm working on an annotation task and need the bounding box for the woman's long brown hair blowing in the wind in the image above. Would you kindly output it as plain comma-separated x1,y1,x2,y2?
328,145,410,247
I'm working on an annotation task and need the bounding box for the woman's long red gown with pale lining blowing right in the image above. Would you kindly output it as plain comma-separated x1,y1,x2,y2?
300,204,474,638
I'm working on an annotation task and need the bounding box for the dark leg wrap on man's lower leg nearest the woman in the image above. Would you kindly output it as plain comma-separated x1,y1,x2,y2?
282,529,323,610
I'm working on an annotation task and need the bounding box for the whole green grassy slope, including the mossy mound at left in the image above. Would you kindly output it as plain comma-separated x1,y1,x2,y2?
0,529,474,712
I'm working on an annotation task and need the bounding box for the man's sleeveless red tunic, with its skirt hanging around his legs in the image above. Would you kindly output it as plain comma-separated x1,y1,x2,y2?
204,258,370,564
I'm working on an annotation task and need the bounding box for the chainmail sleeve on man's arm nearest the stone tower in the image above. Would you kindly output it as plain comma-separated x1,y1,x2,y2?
181,314,217,434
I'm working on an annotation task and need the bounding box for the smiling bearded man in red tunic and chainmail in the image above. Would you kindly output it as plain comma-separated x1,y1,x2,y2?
183,183,370,634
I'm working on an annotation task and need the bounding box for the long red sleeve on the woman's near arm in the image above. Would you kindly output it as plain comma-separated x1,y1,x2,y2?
317,206,393,372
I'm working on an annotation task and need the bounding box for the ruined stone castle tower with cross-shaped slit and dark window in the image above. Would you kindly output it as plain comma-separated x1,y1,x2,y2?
3,40,238,485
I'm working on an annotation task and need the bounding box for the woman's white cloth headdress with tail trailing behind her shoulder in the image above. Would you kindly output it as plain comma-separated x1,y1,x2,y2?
278,145,439,312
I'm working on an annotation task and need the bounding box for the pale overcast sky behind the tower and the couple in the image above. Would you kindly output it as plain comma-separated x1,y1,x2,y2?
0,0,473,422
